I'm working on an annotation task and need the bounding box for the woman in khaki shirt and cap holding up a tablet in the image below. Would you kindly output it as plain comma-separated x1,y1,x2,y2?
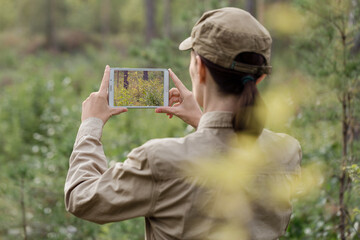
65,8,301,239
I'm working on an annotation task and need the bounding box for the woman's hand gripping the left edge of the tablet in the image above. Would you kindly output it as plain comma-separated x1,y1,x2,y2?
81,65,127,124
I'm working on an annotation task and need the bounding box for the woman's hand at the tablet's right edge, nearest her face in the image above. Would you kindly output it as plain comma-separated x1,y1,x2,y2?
155,69,202,128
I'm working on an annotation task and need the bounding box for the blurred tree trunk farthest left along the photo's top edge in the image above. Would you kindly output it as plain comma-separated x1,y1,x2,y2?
45,0,56,49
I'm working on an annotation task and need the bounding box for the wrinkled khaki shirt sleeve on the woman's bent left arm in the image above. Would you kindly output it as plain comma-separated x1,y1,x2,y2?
64,118,154,224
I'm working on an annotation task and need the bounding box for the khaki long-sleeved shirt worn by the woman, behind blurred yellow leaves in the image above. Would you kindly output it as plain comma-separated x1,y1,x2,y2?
65,112,301,240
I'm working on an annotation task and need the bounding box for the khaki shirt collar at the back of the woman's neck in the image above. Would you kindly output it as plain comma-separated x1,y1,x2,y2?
198,111,234,130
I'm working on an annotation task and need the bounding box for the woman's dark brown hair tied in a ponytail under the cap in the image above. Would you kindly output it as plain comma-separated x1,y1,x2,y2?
200,52,265,137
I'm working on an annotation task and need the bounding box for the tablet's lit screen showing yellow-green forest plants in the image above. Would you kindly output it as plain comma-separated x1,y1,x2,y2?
114,71,164,107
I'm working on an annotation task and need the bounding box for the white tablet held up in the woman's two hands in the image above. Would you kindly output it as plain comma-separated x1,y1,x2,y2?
109,68,169,108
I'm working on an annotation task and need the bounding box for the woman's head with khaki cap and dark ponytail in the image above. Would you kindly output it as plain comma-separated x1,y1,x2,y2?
179,8,272,135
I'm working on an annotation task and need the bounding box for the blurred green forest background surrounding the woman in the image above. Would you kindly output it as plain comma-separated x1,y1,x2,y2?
0,0,360,240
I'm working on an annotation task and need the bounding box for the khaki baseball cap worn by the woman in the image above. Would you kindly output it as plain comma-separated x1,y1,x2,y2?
179,7,272,74
